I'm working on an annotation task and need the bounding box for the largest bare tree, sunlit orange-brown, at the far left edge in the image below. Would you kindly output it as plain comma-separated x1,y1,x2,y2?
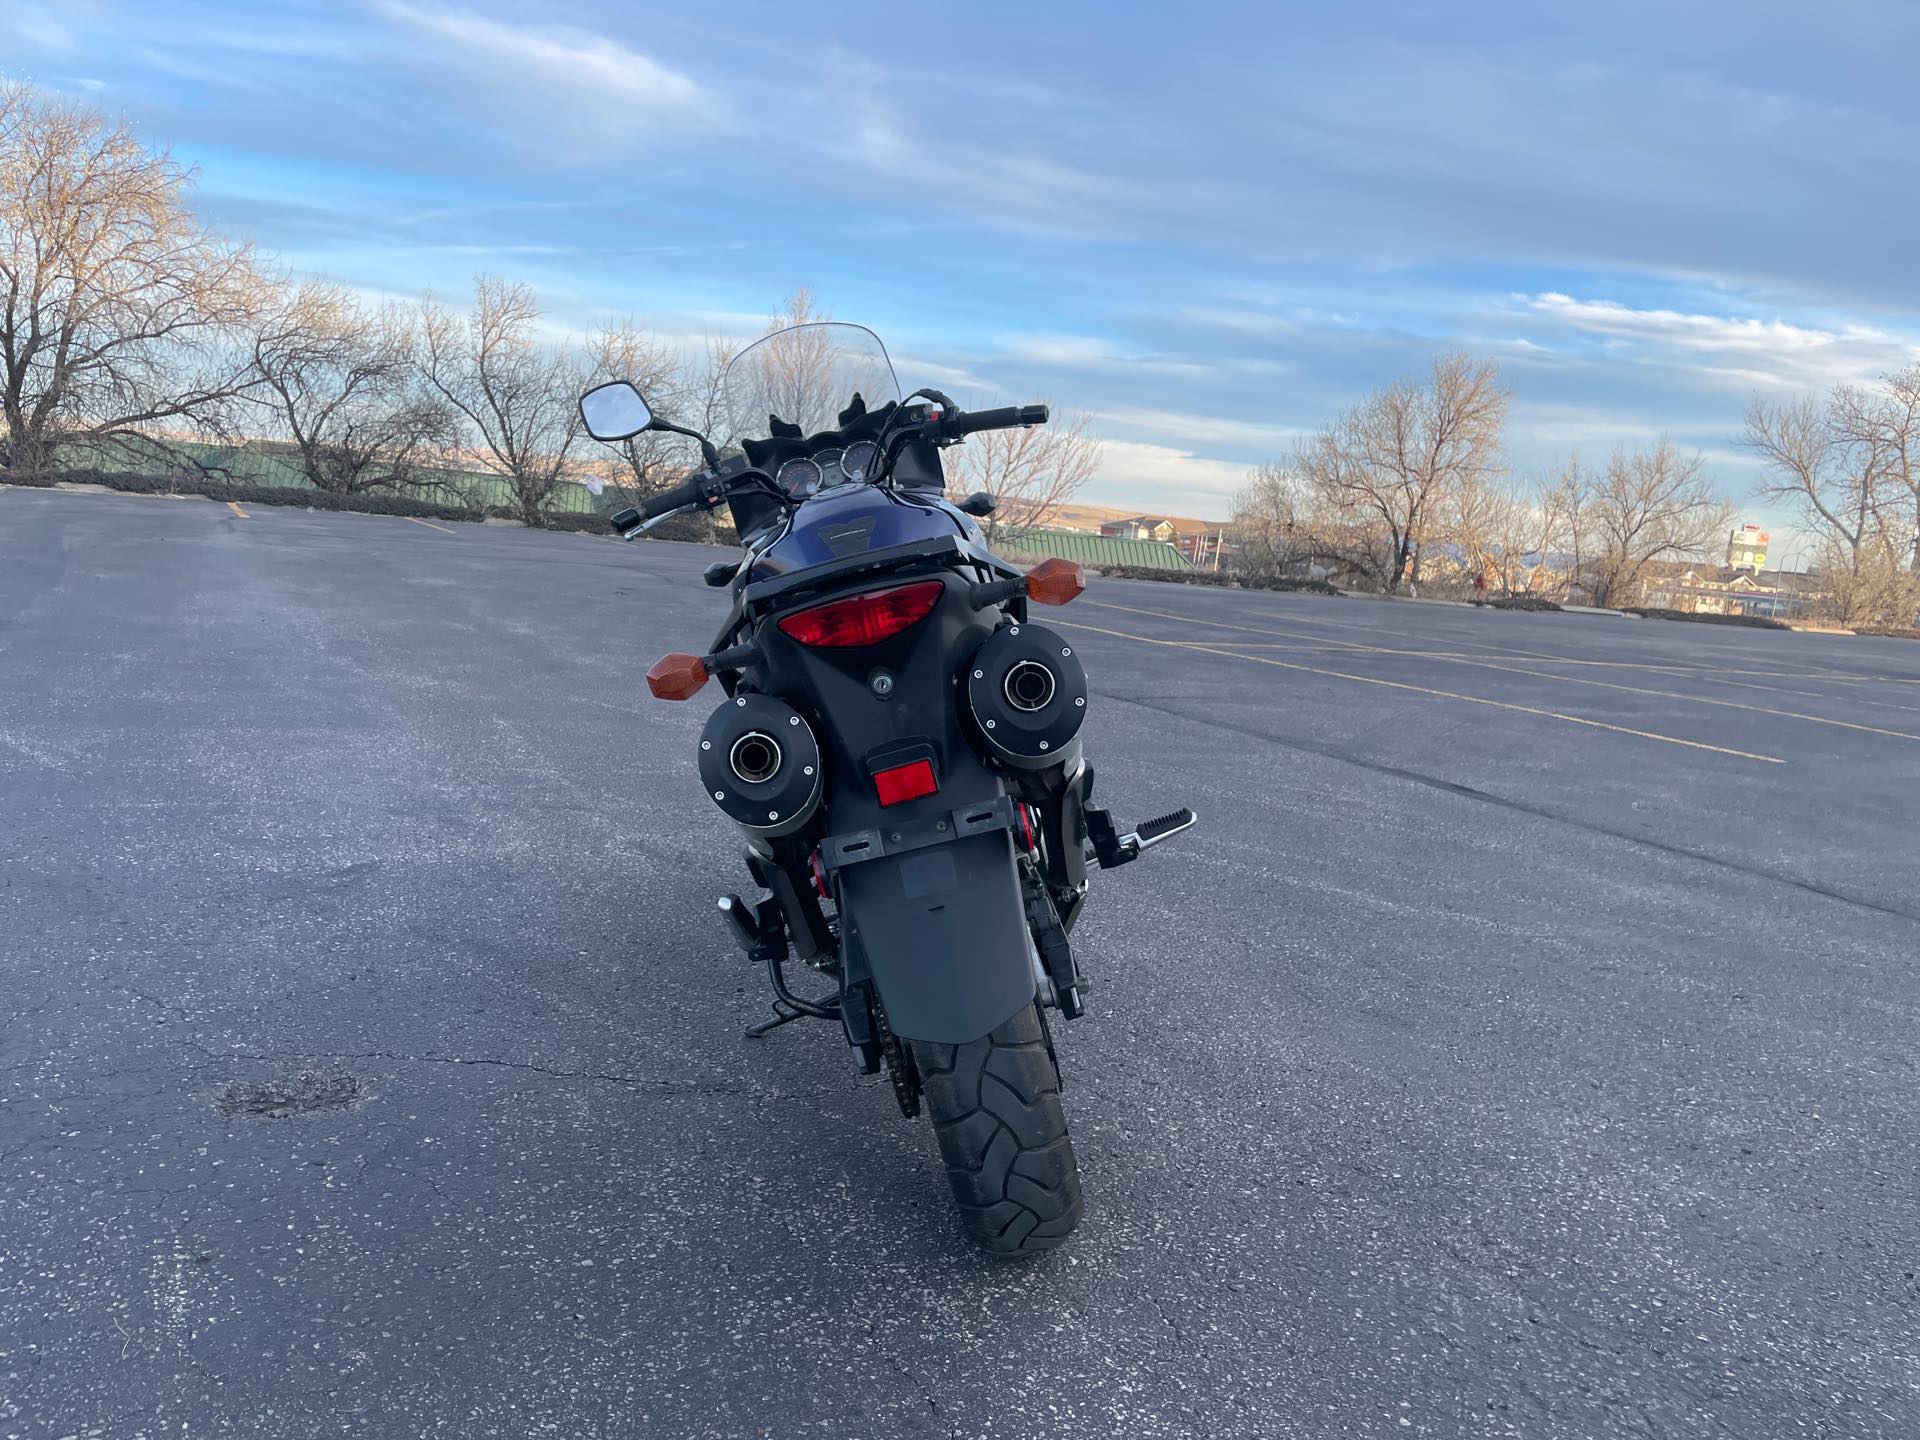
0,83,271,470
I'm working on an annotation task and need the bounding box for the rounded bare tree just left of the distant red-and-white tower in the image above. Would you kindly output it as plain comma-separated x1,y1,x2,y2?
1578,440,1734,605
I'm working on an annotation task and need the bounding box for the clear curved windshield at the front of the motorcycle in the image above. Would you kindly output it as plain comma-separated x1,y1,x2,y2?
720,324,900,438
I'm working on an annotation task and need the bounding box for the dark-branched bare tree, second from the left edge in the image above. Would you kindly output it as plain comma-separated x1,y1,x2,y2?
252,282,459,495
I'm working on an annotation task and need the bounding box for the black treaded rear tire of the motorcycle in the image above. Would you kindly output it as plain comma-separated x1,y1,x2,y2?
912,1006,1083,1258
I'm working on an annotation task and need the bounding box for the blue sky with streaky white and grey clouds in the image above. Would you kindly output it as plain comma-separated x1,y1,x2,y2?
0,0,1920,549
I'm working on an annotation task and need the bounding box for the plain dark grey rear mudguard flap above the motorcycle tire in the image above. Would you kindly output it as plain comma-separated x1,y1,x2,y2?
837,829,1035,1044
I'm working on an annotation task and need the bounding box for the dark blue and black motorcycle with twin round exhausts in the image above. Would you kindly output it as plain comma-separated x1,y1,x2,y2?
580,324,1194,1256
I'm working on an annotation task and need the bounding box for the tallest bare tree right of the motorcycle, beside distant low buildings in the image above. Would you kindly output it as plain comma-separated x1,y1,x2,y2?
1294,355,1507,591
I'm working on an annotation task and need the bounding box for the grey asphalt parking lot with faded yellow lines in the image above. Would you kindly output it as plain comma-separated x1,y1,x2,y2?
11,490,1920,1440
